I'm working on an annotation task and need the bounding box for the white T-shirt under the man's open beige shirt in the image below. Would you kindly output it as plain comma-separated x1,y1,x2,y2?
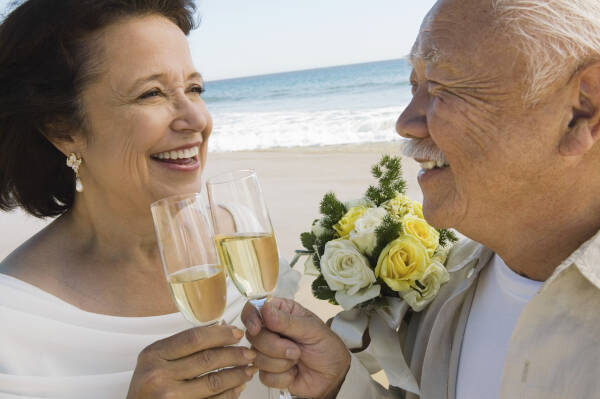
456,255,543,399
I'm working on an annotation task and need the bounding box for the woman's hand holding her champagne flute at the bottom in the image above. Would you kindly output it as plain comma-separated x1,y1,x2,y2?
127,325,257,399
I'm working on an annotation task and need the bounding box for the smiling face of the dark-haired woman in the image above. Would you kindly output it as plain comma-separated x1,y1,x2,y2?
80,16,212,213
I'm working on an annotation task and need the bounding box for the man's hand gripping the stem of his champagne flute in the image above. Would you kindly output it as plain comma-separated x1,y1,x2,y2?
242,298,350,399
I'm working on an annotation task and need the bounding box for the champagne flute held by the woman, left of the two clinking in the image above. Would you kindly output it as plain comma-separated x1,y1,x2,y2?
150,193,227,326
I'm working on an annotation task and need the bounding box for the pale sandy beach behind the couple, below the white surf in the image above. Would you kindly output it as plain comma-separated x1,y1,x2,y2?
0,142,421,319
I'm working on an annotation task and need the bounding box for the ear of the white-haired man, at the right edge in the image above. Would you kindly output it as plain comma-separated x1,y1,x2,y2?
559,62,600,156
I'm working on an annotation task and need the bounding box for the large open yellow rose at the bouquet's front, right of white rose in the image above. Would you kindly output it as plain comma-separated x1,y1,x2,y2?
375,234,429,291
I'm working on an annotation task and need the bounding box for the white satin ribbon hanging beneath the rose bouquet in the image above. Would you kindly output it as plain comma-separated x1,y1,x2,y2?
331,297,420,395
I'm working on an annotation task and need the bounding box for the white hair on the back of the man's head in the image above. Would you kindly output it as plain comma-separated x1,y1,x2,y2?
493,0,600,103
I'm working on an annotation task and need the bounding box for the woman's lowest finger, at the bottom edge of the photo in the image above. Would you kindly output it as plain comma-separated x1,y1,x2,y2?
181,367,258,398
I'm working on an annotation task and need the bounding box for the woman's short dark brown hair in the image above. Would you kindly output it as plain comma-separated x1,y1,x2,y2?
0,0,195,217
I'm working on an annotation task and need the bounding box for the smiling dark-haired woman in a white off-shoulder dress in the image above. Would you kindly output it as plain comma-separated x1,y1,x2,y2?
0,0,297,399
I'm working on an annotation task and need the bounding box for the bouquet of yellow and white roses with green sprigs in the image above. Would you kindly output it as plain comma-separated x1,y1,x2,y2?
301,156,457,312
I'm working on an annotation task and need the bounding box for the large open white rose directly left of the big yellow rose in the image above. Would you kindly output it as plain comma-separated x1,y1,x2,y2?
321,240,376,295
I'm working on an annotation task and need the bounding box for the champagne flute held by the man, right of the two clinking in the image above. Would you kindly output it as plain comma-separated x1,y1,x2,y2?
207,170,291,399
